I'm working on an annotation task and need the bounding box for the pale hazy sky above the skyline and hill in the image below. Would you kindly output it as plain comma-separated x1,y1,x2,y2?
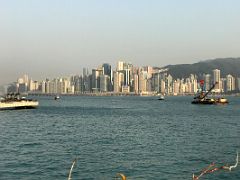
0,0,240,84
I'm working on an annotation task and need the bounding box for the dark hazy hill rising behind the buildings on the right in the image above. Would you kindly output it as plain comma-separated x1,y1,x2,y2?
164,58,240,79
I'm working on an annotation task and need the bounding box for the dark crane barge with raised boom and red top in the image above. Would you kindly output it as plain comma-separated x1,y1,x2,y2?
192,80,228,104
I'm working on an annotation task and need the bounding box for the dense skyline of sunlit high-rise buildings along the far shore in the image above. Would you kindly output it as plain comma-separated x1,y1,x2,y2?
5,61,240,95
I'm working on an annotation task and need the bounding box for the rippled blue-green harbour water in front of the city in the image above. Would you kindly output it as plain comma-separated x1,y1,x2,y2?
0,97,240,180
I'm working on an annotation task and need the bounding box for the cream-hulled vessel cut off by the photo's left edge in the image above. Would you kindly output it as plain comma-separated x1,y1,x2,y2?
0,93,39,110
